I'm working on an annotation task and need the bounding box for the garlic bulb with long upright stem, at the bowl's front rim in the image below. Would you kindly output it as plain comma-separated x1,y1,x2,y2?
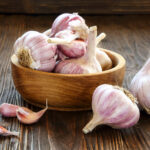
55,26,102,74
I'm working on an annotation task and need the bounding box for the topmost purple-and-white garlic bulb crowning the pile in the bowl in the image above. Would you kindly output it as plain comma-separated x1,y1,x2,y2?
50,13,88,40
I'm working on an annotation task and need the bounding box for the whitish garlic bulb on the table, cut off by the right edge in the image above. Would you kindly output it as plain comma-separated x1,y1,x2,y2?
130,58,150,114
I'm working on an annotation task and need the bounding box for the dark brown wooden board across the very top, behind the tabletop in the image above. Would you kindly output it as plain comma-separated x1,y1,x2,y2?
0,0,150,14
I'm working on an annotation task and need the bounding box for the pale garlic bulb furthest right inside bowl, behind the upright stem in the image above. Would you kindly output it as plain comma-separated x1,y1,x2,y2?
96,48,112,71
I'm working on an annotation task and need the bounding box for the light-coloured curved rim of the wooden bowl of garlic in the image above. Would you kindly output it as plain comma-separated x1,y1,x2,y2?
11,48,126,77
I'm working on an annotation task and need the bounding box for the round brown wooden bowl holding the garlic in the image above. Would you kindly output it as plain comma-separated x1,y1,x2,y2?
11,49,125,111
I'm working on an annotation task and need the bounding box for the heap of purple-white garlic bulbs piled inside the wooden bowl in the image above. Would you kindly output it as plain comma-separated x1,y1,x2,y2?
14,13,112,74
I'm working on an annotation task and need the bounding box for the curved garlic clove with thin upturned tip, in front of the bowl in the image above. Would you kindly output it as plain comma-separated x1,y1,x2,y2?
16,102,48,124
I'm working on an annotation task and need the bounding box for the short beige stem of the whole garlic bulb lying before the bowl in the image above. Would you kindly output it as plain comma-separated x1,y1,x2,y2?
82,115,100,134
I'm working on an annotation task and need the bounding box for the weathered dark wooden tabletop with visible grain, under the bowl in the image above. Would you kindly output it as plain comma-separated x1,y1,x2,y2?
0,15,150,150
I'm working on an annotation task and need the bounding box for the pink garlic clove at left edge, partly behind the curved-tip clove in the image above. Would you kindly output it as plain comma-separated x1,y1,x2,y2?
0,103,19,117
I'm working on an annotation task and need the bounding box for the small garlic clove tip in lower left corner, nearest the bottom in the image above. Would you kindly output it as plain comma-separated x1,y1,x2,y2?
0,126,19,137
